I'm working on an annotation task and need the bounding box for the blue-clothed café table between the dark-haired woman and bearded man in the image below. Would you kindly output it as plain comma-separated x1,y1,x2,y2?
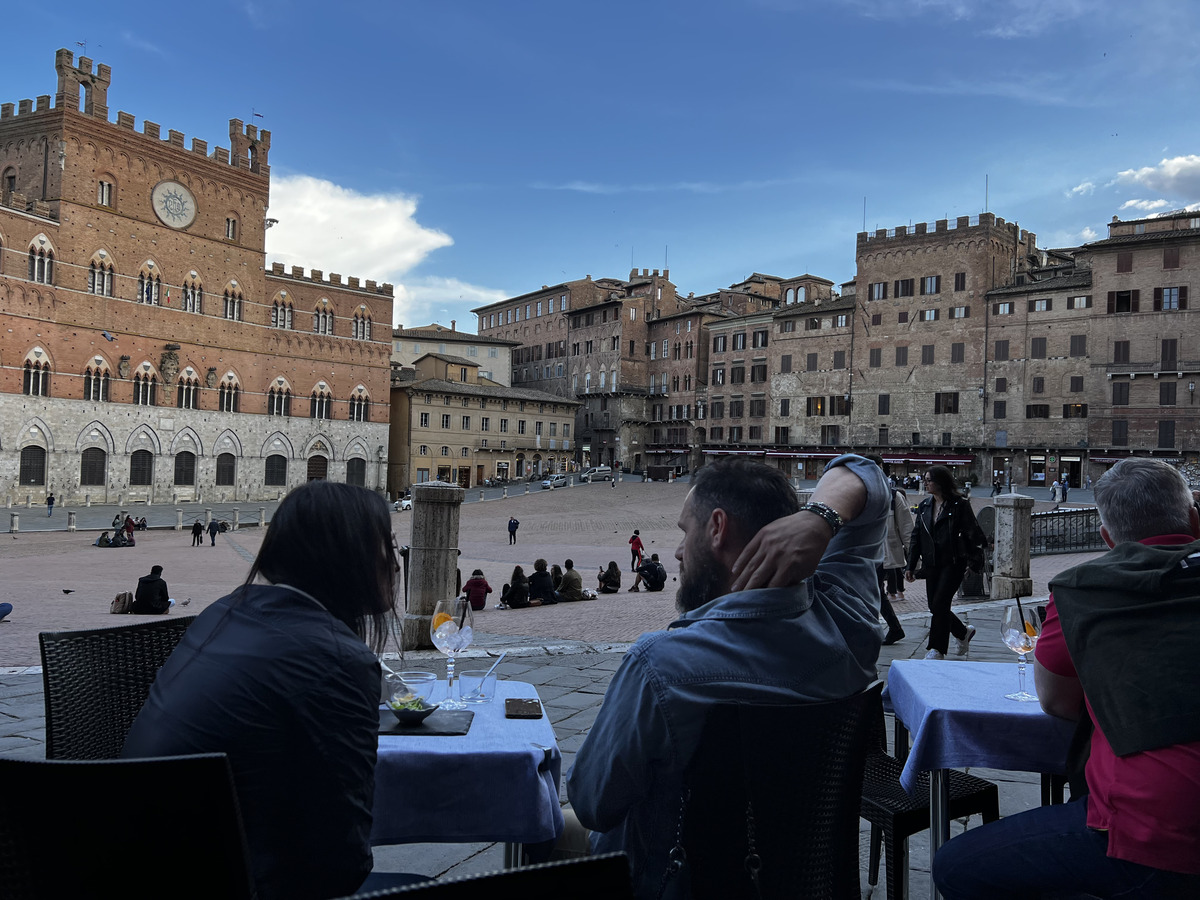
371,682,563,865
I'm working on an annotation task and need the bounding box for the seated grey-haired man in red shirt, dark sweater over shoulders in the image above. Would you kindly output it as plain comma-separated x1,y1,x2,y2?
934,457,1200,900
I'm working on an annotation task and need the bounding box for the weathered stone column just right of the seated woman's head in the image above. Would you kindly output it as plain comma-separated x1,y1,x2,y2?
401,481,467,650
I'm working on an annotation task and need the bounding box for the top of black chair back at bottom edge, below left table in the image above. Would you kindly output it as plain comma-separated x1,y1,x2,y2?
333,853,634,900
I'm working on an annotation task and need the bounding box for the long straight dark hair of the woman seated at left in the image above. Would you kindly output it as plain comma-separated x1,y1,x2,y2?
246,481,397,653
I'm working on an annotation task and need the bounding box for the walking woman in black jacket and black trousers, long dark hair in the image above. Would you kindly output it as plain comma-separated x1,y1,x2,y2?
905,466,986,659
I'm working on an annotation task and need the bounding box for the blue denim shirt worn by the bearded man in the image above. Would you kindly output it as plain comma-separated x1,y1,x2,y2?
566,456,890,898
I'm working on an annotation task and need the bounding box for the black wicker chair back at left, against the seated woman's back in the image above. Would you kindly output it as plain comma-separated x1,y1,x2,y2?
37,616,196,760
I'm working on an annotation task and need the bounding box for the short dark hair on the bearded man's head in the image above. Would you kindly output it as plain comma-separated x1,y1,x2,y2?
691,456,800,541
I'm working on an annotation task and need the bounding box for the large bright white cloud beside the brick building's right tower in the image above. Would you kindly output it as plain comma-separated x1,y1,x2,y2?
266,175,454,318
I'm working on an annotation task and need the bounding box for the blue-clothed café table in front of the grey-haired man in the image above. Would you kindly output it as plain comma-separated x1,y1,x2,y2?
887,660,1075,898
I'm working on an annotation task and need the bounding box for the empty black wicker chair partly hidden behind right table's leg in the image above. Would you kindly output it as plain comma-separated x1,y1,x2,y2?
860,700,1000,900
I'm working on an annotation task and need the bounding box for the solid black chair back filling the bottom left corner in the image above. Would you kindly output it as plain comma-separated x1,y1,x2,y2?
0,754,254,900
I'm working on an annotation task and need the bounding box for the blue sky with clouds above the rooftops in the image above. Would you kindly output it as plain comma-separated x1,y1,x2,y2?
7,0,1200,330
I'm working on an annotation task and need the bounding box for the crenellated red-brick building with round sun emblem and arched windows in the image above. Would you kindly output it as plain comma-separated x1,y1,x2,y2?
0,49,392,503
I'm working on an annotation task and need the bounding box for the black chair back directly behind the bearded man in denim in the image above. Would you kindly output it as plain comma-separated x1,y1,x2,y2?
664,684,882,900
